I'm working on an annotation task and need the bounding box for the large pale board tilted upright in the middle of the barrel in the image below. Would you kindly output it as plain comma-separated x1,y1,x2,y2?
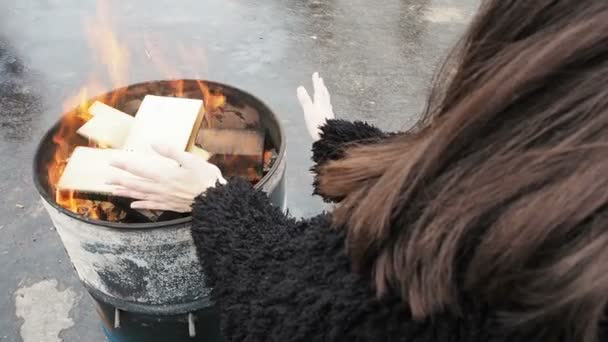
123,95,204,151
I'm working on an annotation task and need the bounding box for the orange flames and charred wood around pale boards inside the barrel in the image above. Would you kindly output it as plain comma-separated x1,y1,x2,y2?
47,81,277,223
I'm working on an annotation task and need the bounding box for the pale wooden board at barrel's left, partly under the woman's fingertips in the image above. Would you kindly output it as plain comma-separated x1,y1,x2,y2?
57,146,179,194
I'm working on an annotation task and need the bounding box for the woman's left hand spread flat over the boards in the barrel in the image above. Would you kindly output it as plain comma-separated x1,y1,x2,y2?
109,146,226,213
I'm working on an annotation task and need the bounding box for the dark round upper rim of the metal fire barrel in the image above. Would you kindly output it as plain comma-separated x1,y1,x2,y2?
33,79,287,230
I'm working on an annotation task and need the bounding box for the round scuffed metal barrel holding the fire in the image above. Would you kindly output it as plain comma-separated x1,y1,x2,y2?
34,81,286,342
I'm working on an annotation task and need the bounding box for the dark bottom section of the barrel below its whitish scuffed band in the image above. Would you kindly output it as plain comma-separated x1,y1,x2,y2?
91,295,223,342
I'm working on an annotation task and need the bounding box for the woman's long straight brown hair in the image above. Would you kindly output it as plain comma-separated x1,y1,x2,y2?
317,0,608,341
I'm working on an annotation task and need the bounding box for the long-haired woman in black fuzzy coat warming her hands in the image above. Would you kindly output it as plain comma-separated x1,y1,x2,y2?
107,0,608,342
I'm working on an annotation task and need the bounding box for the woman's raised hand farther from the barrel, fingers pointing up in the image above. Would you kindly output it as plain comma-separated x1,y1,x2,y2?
298,72,334,141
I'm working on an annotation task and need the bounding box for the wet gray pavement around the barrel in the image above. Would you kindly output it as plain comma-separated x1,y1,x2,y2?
0,0,477,342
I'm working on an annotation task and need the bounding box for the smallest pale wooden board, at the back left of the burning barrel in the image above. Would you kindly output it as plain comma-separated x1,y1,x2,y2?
77,101,134,148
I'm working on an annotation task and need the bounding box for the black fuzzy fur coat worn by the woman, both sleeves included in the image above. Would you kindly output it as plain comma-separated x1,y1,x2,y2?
192,120,498,342
